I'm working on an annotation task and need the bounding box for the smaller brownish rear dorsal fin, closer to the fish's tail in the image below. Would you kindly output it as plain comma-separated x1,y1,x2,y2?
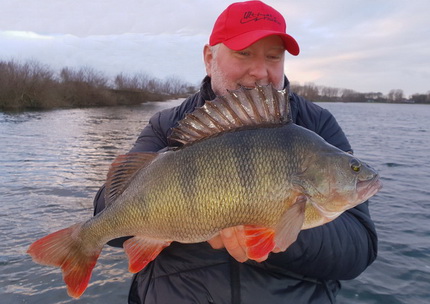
105,153,158,206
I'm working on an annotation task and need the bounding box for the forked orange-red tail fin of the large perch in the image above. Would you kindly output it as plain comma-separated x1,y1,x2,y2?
27,223,102,298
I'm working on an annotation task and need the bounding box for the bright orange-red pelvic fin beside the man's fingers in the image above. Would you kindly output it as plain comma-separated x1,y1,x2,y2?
244,225,275,260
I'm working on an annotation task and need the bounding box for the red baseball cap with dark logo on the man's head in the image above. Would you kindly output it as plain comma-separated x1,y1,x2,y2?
209,1,300,56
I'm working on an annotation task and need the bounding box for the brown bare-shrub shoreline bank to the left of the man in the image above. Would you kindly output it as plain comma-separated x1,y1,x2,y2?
0,61,196,111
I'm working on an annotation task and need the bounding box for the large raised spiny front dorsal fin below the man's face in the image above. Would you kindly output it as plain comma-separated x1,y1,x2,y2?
170,85,291,145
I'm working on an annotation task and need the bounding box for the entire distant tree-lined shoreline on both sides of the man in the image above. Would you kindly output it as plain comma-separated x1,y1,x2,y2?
0,61,430,111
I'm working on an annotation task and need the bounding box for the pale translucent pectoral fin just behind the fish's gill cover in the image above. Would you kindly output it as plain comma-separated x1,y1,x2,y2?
275,195,307,251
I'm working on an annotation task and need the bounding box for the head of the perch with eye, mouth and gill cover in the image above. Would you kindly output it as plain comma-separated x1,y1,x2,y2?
300,149,382,219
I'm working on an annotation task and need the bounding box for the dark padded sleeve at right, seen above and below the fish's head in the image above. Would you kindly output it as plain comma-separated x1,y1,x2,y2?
268,94,377,280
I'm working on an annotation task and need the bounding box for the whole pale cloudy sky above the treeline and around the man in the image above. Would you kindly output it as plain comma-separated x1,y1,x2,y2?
0,0,430,97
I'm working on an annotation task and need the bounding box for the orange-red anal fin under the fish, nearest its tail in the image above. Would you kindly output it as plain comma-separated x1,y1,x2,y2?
123,236,170,273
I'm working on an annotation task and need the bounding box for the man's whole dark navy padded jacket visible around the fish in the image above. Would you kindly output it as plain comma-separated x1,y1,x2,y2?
95,77,377,304
